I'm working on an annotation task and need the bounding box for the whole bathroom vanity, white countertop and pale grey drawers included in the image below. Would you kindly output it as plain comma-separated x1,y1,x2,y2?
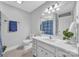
32,36,78,57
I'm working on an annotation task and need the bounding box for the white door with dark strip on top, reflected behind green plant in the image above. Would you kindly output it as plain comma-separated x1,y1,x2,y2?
58,12,74,37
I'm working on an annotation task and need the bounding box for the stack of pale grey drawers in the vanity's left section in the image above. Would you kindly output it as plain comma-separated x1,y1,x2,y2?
37,41,56,57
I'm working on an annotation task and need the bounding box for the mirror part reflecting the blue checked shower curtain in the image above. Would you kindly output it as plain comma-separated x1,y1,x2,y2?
40,14,56,35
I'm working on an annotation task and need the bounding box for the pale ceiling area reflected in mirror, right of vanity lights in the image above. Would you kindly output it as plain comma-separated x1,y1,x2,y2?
57,1,75,14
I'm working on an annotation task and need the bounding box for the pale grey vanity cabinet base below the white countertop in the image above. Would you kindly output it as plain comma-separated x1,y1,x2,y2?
33,39,78,57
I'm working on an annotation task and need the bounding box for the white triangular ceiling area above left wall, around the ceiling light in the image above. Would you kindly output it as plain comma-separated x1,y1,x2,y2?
3,1,45,12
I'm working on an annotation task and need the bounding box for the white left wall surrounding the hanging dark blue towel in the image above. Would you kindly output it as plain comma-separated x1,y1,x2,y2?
0,3,30,48
